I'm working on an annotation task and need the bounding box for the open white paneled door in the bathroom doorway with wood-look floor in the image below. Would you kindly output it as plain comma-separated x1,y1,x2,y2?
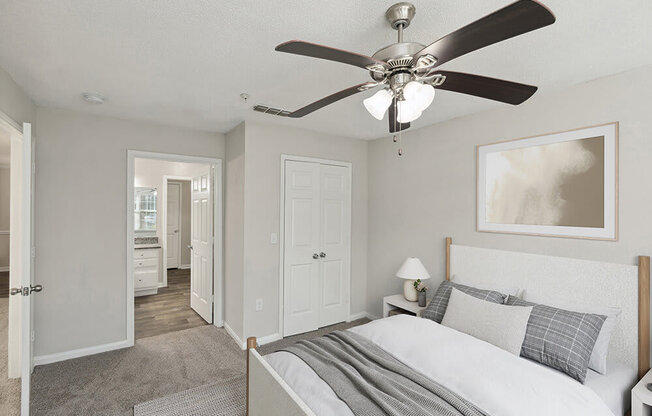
190,171,213,324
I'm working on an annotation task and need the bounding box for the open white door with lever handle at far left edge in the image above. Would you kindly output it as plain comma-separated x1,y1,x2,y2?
9,123,35,416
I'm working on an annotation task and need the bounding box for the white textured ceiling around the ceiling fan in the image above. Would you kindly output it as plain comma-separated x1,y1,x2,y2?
0,0,652,138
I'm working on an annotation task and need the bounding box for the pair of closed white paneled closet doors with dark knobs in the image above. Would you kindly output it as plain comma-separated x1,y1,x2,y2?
283,161,351,336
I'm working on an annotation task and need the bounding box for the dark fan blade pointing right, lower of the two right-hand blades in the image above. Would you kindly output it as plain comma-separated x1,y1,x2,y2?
435,71,537,105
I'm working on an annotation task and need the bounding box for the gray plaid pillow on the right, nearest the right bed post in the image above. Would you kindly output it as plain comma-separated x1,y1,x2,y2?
505,296,607,383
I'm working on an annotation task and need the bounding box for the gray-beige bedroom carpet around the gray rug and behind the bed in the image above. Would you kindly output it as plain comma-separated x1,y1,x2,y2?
31,319,368,416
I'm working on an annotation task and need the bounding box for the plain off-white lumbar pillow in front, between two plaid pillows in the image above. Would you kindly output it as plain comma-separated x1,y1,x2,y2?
441,288,532,356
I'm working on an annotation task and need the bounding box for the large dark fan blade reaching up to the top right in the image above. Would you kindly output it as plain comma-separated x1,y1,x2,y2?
415,0,555,66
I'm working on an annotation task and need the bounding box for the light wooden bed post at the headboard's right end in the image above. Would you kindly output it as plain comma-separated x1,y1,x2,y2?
638,256,650,379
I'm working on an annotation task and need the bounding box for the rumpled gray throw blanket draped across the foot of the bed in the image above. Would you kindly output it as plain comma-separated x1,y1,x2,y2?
283,331,486,416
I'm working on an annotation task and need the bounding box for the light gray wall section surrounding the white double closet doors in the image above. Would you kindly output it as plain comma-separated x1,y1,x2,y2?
244,123,367,337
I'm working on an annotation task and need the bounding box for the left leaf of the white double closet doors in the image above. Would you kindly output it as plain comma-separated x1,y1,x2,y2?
283,161,320,336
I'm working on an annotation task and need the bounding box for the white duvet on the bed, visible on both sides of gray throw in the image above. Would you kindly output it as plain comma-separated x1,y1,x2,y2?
265,315,613,416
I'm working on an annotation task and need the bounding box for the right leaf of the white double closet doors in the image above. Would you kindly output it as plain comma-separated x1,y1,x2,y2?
319,165,351,327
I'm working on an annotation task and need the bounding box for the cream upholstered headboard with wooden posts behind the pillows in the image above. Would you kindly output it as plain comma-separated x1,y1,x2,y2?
446,238,650,377
